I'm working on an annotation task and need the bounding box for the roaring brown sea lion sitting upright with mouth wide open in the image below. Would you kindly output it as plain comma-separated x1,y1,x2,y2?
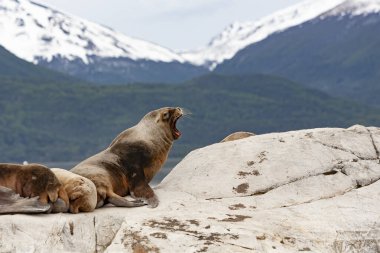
71,107,183,208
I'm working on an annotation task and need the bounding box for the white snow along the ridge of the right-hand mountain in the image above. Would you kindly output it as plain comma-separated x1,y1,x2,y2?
181,0,380,69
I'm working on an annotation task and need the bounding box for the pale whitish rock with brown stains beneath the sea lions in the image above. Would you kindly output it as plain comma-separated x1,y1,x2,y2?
0,126,380,252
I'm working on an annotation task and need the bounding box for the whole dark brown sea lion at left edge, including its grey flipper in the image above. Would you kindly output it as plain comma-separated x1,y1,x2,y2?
0,163,61,213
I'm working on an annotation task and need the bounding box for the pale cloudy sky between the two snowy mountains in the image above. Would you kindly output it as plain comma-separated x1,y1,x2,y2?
35,0,301,50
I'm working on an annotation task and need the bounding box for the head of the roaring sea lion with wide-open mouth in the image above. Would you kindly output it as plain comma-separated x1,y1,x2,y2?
141,107,183,140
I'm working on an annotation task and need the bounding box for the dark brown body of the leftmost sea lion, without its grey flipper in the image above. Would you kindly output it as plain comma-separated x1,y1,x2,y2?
0,163,61,204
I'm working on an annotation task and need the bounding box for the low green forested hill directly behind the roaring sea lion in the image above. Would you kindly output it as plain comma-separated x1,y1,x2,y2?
0,75,380,162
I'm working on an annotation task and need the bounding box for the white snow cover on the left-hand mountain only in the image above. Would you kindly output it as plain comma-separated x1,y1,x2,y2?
0,0,183,63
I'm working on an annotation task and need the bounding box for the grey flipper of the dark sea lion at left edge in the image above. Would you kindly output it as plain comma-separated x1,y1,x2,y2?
0,186,50,214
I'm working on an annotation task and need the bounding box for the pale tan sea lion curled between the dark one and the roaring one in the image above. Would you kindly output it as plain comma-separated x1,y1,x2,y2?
51,168,97,213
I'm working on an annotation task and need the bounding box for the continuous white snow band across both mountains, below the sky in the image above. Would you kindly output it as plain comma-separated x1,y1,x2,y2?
0,0,380,70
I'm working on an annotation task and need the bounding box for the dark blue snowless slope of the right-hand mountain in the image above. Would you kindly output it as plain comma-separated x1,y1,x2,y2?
216,4,380,106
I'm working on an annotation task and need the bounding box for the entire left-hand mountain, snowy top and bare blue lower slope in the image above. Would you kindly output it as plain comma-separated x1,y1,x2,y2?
0,0,205,83
